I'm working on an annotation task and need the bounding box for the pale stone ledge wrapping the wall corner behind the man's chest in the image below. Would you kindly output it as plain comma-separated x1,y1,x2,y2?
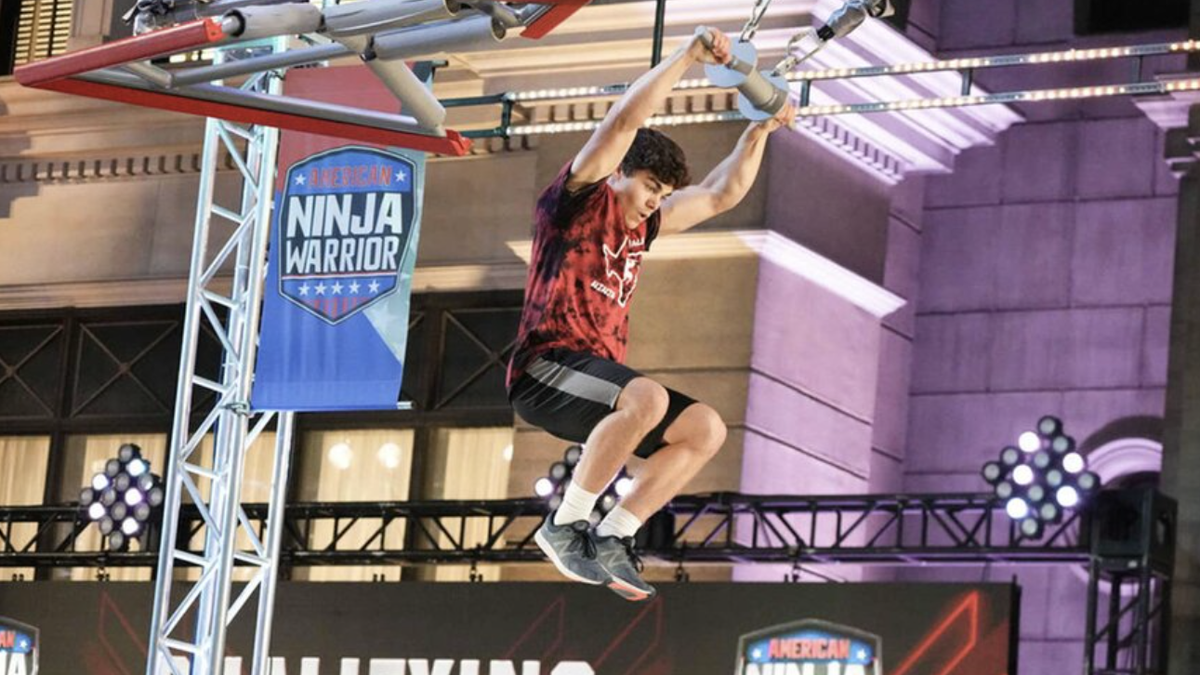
508,229,905,318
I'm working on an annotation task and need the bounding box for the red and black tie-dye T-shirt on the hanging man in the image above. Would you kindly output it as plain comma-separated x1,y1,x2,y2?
508,163,660,387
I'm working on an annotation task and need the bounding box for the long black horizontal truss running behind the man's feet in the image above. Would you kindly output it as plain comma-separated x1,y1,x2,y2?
0,492,1092,567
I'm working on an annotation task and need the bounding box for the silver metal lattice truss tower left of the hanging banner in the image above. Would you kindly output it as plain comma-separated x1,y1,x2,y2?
146,41,294,675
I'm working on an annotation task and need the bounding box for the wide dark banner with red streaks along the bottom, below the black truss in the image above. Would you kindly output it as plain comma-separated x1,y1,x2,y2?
0,581,1019,675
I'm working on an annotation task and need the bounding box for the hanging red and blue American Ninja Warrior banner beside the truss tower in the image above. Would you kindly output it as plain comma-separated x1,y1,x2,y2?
251,66,425,411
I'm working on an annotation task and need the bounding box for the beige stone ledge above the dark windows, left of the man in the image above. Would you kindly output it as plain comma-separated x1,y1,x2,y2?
0,262,526,311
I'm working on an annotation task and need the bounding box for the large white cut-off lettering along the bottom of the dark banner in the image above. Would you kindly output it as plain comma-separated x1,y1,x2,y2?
249,652,595,675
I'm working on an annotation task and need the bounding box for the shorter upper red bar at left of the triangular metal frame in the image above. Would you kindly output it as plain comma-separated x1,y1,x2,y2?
13,18,224,86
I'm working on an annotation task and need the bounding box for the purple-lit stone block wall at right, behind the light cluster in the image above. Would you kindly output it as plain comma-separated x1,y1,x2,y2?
899,0,1182,675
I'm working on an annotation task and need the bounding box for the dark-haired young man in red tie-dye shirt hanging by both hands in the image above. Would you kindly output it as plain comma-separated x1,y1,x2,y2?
508,27,796,601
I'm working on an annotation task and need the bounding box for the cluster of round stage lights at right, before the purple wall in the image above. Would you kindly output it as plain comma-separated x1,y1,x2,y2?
983,416,1100,538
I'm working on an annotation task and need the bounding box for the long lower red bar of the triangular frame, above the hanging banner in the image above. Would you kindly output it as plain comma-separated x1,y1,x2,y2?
30,79,470,157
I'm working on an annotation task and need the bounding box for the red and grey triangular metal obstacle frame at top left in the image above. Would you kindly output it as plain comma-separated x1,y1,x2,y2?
13,0,587,155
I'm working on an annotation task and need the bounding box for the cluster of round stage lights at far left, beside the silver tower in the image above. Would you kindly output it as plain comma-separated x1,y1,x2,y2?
79,443,166,551
